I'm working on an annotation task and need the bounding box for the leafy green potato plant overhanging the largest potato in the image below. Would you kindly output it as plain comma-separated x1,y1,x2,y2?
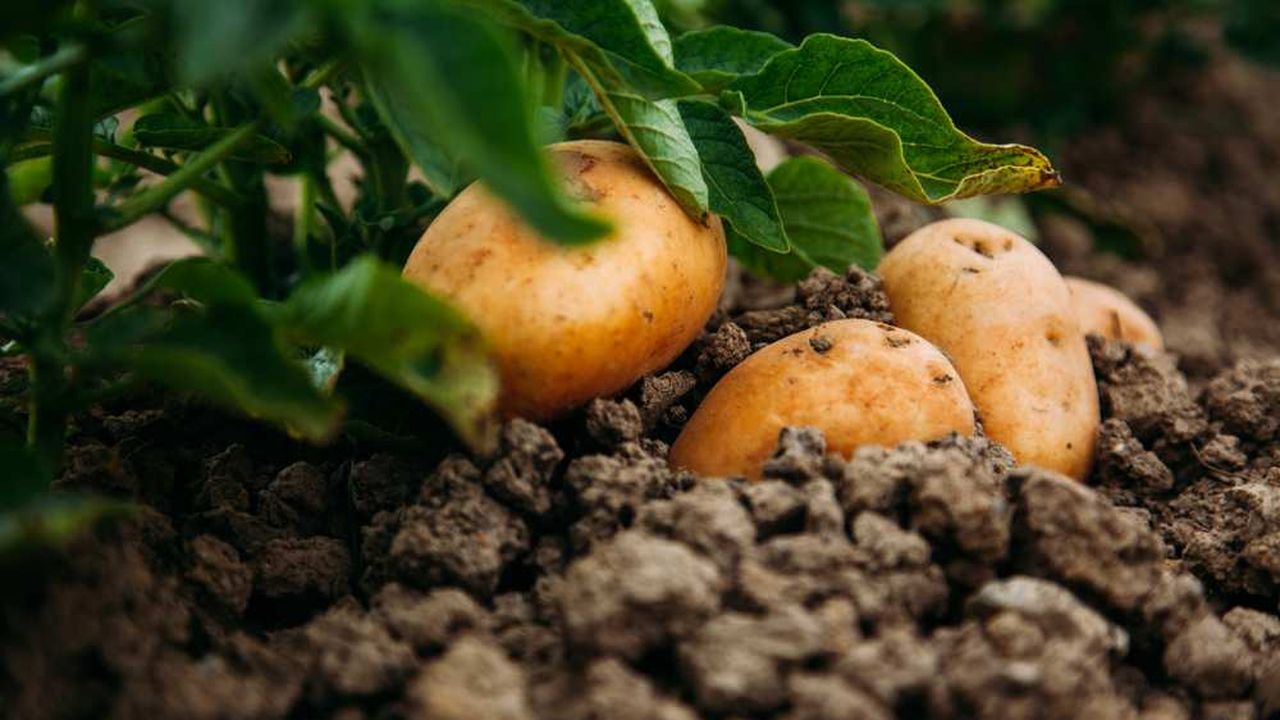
0,0,1057,532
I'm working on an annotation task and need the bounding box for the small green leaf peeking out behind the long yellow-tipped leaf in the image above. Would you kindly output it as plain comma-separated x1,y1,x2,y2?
675,26,792,92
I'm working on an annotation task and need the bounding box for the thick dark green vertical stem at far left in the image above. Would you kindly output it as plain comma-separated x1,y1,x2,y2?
27,41,96,471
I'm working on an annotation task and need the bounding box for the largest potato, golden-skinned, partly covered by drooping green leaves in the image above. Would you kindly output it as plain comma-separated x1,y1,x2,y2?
404,141,727,419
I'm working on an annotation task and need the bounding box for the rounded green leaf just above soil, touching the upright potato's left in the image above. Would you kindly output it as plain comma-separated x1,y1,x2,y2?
728,156,883,282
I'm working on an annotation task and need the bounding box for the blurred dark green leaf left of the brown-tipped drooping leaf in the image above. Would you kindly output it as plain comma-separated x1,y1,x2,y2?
87,258,342,439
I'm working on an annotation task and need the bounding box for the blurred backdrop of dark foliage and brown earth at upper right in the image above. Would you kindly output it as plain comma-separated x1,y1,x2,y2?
662,0,1280,378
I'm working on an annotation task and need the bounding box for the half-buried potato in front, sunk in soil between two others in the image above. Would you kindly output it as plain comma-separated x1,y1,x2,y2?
671,320,974,479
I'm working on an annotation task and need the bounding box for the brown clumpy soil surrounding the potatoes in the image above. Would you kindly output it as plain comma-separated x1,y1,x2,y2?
0,46,1280,720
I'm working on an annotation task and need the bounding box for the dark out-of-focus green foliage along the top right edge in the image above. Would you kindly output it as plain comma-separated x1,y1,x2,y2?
706,0,1280,142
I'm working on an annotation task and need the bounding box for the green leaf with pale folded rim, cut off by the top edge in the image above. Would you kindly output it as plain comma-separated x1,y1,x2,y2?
462,0,699,100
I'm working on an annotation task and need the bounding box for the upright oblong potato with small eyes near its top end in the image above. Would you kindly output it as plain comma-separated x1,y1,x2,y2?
879,219,1100,479
